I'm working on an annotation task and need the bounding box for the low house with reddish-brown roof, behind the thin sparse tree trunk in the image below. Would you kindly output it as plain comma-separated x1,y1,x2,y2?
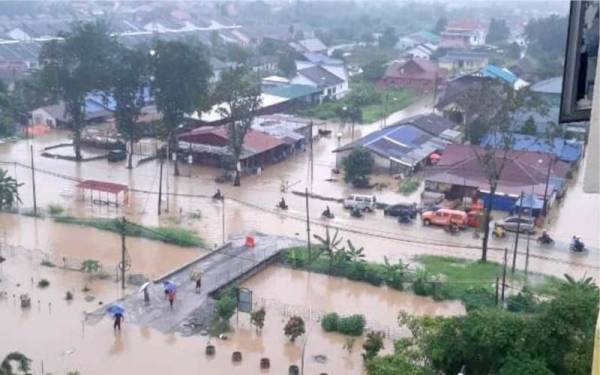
177,126,289,172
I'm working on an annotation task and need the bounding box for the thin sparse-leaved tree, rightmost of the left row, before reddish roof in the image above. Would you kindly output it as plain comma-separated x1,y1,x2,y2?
215,66,262,186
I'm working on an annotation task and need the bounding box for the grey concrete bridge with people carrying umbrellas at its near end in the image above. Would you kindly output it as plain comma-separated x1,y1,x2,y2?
93,233,305,334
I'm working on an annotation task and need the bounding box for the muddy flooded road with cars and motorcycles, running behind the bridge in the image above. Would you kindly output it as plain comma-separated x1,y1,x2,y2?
0,98,600,276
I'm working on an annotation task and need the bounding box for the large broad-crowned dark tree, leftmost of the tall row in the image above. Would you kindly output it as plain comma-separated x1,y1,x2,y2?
39,21,115,160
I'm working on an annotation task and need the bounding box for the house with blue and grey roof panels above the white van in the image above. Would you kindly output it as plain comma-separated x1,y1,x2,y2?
333,122,448,174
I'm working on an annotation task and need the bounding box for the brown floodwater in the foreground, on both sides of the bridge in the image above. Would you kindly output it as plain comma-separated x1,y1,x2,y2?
0,248,464,375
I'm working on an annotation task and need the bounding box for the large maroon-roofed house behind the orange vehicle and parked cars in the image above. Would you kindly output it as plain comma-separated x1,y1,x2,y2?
425,144,569,212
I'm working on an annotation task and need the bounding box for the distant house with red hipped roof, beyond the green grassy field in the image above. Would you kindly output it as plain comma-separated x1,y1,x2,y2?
379,59,446,91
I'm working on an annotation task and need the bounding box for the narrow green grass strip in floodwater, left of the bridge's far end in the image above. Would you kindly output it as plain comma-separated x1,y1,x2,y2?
54,216,204,247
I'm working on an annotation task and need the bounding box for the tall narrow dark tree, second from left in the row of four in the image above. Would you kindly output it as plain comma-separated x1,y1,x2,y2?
111,46,148,169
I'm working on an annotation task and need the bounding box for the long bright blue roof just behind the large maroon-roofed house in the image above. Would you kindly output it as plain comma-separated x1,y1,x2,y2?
481,134,582,163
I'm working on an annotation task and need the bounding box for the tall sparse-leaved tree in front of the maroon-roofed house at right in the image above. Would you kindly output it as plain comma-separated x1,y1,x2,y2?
457,81,546,262
